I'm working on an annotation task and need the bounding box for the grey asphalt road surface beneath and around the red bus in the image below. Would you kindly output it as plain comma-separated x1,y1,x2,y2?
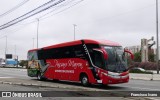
0,68,160,100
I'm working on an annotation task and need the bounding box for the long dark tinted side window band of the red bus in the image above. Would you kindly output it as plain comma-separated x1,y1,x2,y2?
38,45,85,59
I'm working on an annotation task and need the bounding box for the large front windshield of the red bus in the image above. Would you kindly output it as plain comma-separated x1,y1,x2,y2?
103,46,128,72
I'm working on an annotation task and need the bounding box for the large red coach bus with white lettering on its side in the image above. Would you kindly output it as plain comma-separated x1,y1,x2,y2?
28,39,133,86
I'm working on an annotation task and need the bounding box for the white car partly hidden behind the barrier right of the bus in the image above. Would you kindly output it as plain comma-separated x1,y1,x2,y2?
129,67,153,74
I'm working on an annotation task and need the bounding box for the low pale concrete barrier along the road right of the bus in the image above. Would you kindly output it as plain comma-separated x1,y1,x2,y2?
130,73,160,80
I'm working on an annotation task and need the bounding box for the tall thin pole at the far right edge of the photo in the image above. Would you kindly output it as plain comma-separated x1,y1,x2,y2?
156,0,159,74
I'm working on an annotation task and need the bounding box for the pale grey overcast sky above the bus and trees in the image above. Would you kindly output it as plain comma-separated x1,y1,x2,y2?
0,0,159,59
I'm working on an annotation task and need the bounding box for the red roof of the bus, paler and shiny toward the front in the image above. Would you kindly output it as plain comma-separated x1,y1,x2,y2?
29,39,121,52
